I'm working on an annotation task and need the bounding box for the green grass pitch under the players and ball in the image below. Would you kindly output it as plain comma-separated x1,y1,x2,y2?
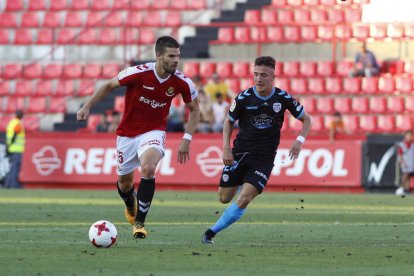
0,189,414,276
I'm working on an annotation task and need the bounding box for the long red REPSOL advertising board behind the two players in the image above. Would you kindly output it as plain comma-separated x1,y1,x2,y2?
20,134,362,188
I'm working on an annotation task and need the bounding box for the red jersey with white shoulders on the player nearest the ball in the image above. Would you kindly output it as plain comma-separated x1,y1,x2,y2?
116,62,198,137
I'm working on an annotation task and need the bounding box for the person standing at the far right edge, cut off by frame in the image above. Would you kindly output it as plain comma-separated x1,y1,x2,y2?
395,130,414,196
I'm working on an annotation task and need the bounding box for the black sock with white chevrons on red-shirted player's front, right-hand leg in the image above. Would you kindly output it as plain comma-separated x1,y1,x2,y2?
135,178,155,223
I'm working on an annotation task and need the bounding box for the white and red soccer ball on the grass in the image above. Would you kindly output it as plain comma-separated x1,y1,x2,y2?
89,220,118,248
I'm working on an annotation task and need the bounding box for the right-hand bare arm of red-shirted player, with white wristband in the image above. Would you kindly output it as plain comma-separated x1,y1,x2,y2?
178,98,200,164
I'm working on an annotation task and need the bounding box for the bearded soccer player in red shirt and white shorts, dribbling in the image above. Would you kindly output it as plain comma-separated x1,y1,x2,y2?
77,36,200,239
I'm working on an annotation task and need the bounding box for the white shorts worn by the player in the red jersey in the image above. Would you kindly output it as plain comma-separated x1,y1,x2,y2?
116,130,165,175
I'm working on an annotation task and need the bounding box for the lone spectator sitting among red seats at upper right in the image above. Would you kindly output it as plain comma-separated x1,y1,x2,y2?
349,42,380,77
